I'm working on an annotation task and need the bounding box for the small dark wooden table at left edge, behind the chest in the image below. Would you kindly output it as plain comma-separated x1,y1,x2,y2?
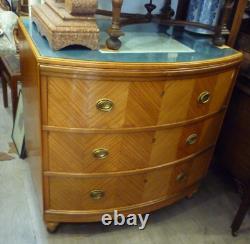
0,55,21,118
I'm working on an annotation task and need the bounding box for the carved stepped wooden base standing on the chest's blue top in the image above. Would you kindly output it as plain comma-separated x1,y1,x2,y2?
31,0,99,50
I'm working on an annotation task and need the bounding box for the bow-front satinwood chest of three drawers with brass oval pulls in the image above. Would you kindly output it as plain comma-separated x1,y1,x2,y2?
19,19,242,231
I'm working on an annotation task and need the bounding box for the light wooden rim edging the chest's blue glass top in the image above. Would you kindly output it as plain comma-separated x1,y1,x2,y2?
18,18,243,71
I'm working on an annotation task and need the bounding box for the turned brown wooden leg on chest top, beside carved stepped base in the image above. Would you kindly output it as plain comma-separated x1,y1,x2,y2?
106,0,124,50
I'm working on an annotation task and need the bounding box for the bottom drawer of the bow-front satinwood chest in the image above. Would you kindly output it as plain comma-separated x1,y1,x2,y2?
48,151,211,211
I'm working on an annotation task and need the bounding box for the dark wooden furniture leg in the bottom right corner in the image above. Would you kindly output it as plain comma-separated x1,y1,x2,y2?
231,184,250,236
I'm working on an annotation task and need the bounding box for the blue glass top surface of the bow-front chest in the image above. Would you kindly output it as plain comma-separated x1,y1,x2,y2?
22,18,237,63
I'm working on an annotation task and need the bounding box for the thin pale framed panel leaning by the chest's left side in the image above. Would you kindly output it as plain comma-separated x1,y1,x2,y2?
11,90,26,159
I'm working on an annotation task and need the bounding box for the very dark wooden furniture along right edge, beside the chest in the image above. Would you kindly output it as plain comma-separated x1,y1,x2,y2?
216,19,250,236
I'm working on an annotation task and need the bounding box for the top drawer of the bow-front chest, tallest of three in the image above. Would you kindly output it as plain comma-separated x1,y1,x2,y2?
42,70,235,129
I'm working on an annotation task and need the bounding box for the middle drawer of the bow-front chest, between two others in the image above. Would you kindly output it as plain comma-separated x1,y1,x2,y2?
44,114,223,173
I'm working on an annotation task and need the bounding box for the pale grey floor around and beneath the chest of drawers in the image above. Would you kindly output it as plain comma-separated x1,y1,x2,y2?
0,84,250,244
